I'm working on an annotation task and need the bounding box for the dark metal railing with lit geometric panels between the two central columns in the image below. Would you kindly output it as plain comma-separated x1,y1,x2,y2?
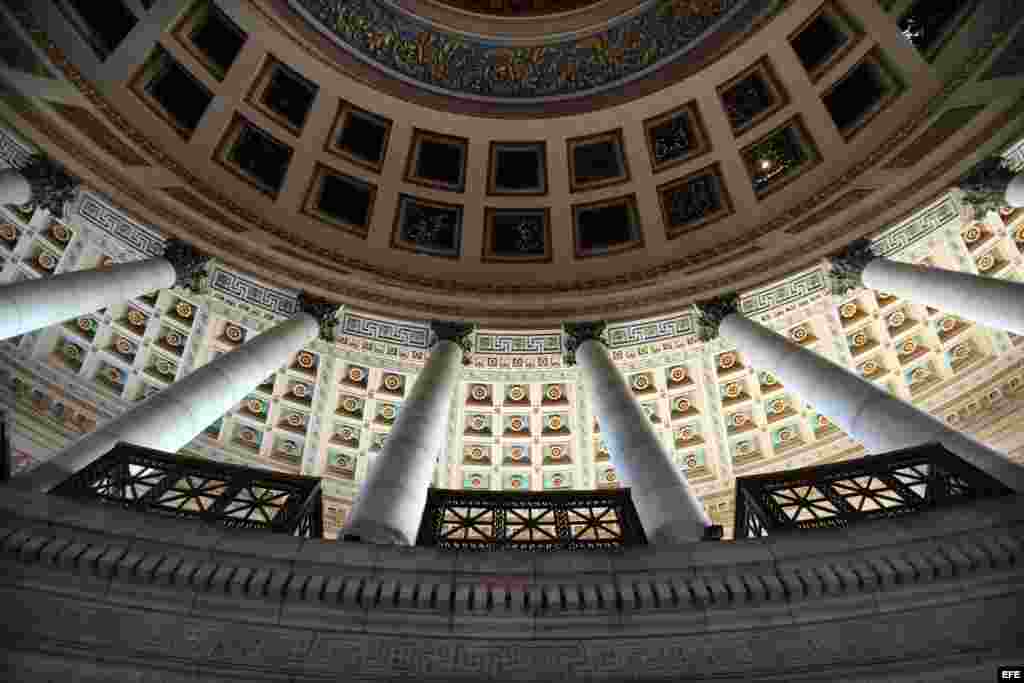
416,488,647,551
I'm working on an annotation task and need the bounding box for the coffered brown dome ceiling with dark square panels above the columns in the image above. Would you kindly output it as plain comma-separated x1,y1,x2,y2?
2,0,1024,329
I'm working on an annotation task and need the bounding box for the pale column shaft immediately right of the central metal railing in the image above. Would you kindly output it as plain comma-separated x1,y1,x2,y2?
575,339,712,543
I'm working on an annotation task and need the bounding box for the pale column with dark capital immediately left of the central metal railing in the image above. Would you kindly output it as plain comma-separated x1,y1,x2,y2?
342,325,469,546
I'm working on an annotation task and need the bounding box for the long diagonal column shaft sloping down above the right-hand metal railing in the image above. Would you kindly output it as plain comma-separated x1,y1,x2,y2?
720,313,1024,492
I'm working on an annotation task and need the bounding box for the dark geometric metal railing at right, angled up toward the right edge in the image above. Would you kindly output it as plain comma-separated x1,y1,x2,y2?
734,443,1013,539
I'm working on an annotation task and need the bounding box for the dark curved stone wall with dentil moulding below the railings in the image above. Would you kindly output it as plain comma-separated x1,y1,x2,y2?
0,490,1024,681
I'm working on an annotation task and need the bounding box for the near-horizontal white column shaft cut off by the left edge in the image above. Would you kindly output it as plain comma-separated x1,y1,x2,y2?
0,256,176,339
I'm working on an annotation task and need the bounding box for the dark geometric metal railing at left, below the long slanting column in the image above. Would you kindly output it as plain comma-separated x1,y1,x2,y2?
51,442,324,539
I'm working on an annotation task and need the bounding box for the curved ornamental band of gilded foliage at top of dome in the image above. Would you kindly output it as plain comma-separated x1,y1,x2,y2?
289,0,761,99
